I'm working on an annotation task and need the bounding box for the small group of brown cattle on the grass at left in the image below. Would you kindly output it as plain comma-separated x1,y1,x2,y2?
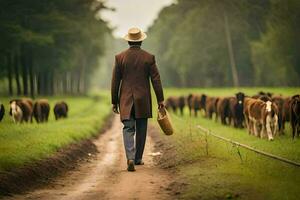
0,98,68,123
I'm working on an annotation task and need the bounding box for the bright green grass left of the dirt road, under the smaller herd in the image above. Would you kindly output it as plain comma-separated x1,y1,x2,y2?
0,94,110,172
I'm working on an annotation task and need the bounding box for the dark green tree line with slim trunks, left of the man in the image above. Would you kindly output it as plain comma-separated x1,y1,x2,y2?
0,0,111,97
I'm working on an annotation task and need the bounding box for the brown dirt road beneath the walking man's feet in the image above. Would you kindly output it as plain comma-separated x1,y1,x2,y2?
8,116,171,200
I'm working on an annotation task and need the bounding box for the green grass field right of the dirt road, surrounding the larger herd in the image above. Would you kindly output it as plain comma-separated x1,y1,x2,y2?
155,88,300,199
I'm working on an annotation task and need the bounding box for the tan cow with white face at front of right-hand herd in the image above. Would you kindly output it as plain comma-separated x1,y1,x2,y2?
248,99,278,141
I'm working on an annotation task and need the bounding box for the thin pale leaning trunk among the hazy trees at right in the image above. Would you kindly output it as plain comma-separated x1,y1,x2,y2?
224,11,239,87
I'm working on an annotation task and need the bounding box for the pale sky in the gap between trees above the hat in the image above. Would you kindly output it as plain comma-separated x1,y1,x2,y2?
101,0,174,37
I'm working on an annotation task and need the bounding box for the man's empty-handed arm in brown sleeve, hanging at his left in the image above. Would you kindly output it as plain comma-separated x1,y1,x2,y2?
111,57,122,113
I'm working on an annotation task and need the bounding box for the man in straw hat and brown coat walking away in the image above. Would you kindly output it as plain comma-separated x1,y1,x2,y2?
111,28,164,171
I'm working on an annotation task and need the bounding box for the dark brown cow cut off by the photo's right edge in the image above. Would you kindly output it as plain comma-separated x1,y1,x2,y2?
290,94,300,139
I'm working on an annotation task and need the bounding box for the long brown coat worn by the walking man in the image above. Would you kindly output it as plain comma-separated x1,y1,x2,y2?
111,46,164,120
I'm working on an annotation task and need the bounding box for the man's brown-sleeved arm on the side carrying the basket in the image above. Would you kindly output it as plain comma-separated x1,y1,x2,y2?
150,56,164,107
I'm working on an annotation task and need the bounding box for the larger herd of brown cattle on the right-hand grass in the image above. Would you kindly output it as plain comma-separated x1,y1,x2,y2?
166,92,300,140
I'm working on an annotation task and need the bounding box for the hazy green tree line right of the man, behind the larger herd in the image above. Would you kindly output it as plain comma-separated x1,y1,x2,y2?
145,0,300,87
